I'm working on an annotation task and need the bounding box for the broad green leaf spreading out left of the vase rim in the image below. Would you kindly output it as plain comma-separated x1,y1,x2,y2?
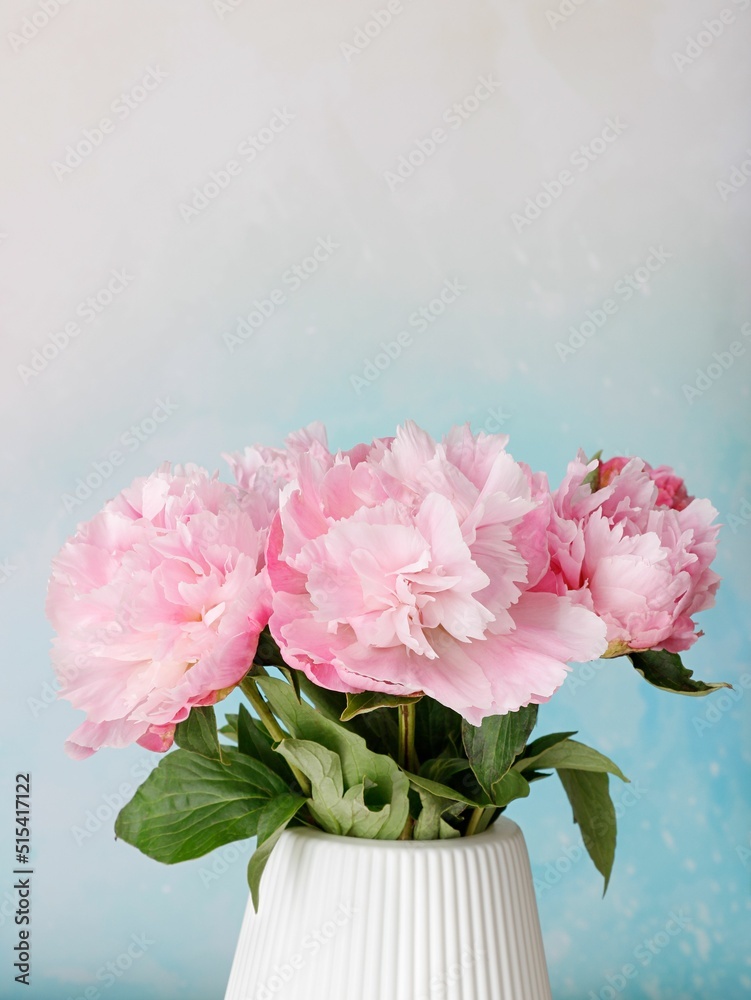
115,747,288,864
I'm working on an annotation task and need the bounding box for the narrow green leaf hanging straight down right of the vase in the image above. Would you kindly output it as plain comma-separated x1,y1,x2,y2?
558,768,616,895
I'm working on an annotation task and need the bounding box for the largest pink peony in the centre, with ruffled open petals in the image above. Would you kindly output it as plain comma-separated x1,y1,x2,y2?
267,423,606,724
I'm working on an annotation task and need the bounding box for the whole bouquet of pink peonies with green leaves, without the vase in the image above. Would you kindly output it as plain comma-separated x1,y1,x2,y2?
48,422,725,900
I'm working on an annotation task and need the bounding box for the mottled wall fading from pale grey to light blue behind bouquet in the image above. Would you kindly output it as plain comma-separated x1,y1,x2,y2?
0,0,751,1000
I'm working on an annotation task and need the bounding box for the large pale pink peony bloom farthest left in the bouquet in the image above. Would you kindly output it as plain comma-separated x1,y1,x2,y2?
47,464,270,758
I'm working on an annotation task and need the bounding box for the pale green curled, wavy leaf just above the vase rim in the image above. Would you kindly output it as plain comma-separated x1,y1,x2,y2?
277,737,409,840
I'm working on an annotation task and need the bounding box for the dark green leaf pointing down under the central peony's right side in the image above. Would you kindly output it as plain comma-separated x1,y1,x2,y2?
462,705,537,801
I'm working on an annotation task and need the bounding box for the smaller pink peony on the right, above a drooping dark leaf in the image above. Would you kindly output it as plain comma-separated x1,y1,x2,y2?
536,452,720,656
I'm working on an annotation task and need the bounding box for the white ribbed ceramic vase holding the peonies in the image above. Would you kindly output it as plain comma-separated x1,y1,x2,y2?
225,817,550,1000
